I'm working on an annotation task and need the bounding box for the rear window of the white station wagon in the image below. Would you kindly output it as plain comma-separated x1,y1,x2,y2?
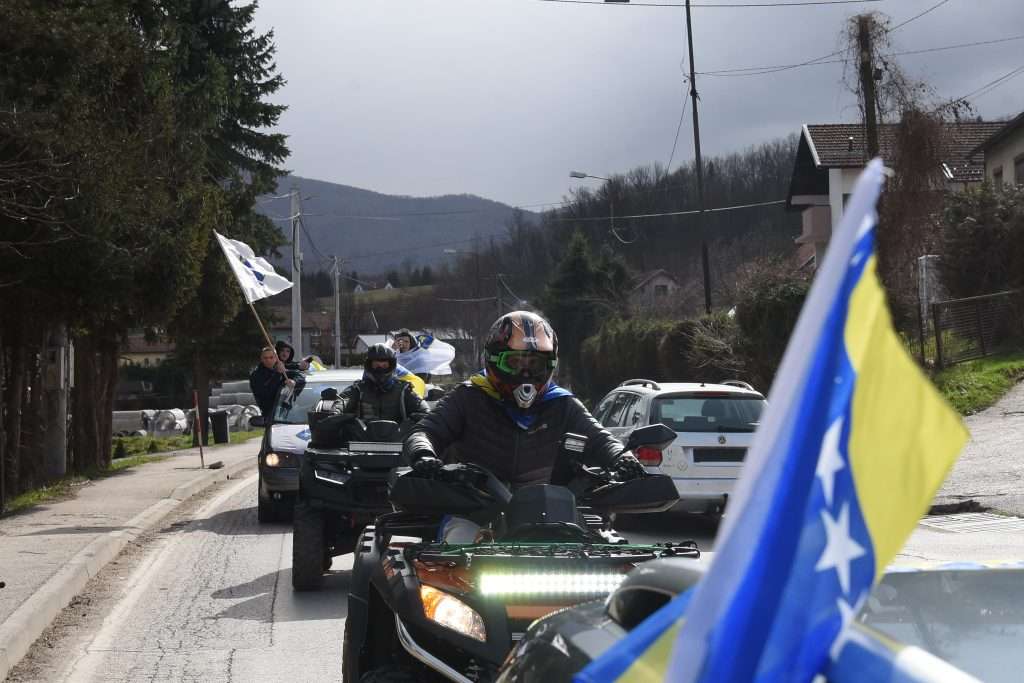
650,393,765,432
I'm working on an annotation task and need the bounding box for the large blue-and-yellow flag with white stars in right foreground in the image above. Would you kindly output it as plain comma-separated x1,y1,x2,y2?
575,160,973,683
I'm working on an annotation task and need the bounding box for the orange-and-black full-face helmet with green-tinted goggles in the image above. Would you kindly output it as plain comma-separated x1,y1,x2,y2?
484,310,558,409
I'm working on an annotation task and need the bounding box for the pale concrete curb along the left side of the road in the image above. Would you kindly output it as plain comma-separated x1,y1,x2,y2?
0,458,256,681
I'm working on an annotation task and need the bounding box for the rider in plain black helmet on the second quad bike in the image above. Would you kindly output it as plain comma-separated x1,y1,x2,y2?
338,344,429,423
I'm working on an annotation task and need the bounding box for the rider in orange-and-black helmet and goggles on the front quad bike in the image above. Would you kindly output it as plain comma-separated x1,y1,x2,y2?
403,311,645,543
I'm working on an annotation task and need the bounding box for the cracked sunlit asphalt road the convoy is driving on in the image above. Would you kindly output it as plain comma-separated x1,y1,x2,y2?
9,476,714,683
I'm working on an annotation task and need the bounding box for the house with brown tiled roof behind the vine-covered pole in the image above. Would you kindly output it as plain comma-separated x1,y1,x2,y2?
786,121,1006,267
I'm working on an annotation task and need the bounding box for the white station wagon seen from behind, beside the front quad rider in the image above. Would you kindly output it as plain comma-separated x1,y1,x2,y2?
594,379,766,513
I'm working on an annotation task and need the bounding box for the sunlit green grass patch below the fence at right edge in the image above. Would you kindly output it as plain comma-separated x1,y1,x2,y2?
935,351,1024,415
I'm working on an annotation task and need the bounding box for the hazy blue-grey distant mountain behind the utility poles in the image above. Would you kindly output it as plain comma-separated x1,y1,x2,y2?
260,175,531,272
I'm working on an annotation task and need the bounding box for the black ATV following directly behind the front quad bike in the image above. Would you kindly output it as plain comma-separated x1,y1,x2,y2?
292,412,414,591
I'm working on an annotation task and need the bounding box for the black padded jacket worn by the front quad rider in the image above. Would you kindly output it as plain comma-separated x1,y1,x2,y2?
403,383,625,487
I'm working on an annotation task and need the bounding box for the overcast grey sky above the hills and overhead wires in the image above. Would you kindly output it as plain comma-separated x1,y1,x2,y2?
251,0,1024,205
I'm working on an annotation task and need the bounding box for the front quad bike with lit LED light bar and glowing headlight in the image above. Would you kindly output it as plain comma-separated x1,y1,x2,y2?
343,425,699,683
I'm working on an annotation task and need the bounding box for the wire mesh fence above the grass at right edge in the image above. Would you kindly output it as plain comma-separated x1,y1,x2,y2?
932,291,1024,368
